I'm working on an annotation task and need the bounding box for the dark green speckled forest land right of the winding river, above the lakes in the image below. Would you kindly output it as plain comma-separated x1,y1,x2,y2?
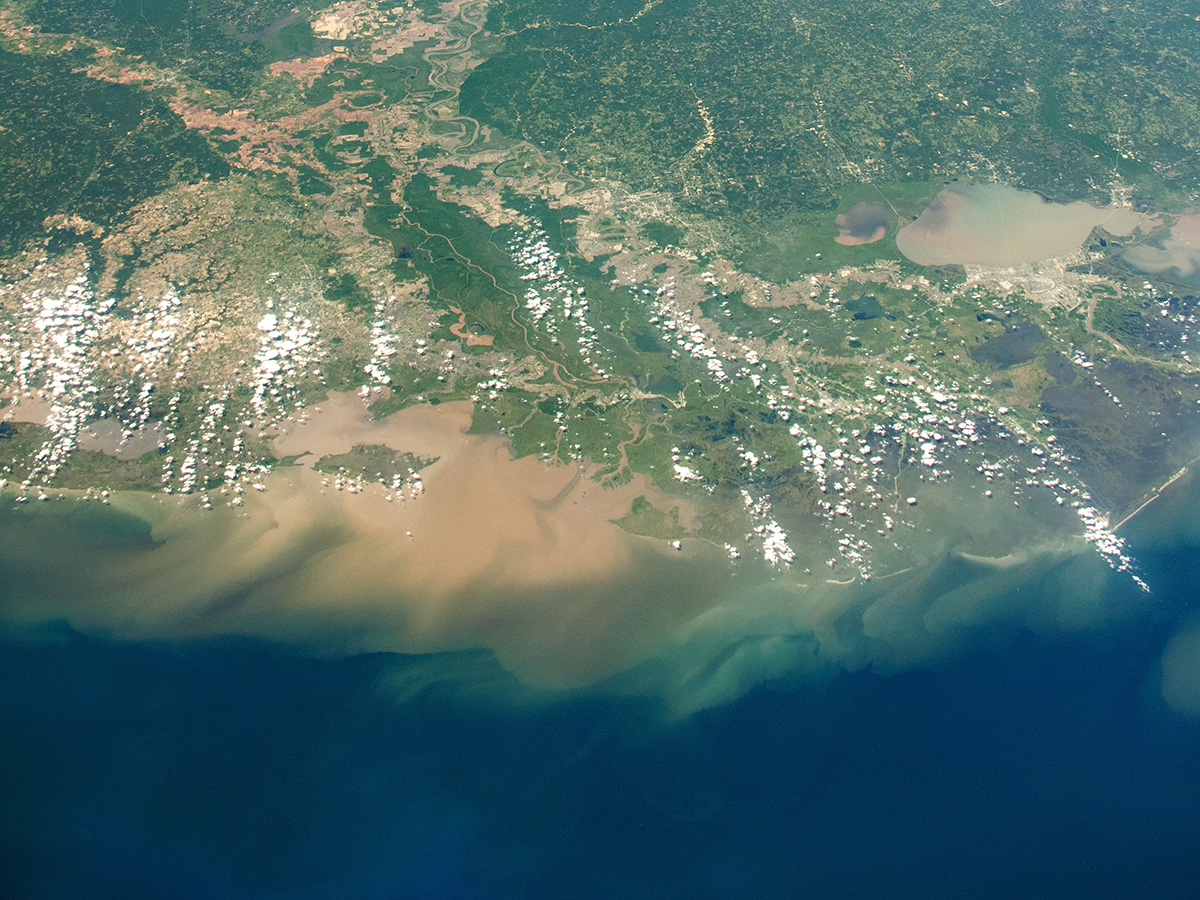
462,0,1200,247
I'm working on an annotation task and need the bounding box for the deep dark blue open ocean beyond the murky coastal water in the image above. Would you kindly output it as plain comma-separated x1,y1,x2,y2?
7,487,1200,900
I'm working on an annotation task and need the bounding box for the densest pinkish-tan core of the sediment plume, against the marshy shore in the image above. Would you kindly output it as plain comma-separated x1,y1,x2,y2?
272,395,700,607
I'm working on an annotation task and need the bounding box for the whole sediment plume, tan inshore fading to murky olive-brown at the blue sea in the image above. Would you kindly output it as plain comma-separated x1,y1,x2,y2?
18,395,730,685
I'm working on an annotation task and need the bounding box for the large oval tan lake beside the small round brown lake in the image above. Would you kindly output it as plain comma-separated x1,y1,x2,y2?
896,182,1157,268
